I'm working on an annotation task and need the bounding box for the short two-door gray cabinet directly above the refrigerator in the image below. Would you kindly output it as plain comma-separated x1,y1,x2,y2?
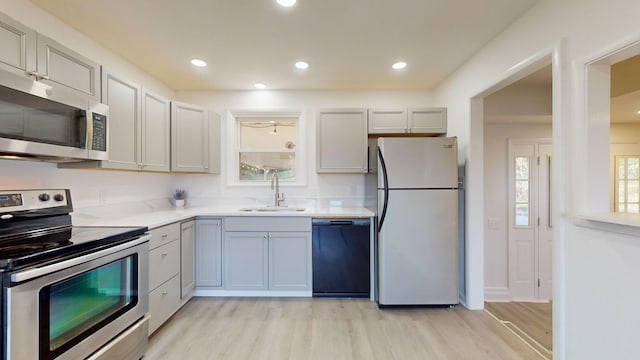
369,107,447,134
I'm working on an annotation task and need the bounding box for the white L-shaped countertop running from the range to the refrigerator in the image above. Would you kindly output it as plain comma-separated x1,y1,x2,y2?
71,203,375,229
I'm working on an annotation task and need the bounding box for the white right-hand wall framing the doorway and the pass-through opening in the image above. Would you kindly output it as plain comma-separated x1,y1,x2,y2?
436,0,640,359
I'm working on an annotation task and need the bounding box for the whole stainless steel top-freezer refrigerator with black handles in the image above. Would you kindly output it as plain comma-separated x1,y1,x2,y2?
377,137,458,306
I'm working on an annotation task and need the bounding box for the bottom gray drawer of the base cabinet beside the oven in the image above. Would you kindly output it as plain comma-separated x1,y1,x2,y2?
149,275,180,335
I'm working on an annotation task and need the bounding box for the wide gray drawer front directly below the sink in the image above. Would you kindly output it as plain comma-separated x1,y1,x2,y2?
224,216,311,231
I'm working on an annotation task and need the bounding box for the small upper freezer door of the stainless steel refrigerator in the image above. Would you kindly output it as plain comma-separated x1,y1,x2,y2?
378,137,458,189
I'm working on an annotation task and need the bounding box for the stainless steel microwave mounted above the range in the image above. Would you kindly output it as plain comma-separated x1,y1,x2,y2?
0,70,109,162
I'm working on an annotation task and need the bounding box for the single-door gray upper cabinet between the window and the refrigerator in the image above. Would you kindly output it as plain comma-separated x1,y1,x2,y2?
316,109,368,173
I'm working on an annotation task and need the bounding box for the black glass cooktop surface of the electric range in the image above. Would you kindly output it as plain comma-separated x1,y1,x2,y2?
0,226,148,271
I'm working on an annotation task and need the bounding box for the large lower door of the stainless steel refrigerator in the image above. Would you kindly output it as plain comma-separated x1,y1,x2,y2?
378,190,458,305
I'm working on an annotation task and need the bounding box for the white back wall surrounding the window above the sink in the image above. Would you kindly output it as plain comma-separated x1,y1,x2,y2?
176,90,439,207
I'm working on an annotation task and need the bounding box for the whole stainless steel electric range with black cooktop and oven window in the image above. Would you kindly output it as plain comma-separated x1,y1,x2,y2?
0,189,150,360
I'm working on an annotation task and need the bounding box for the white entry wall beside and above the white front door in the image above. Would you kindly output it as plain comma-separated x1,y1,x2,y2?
484,123,551,300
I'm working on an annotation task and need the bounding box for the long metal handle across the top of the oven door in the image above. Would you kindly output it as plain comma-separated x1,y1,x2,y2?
11,234,151,283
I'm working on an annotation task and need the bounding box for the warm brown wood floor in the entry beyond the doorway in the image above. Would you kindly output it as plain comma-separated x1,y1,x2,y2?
485,302,553,355
